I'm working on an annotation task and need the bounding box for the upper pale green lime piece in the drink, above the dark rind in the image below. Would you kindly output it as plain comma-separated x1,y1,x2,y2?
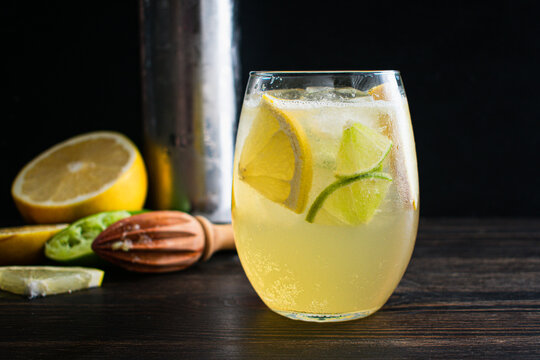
335,123,392,177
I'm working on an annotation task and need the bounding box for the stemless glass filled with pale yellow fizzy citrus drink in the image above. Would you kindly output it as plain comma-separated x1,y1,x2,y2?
232,71,419,322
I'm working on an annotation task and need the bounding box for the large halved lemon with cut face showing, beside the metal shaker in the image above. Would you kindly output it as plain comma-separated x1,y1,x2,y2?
11,131,147,224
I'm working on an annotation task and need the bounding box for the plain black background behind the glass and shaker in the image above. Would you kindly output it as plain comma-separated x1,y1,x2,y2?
0,0,540,220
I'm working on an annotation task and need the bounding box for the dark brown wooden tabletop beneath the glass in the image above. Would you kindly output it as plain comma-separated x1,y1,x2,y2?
0,219,540,360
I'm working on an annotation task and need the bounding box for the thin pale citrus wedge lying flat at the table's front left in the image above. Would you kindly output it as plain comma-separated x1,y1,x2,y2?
0,266,103,298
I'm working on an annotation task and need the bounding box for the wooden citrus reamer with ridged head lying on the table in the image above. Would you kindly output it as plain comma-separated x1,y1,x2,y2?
92,211,235,273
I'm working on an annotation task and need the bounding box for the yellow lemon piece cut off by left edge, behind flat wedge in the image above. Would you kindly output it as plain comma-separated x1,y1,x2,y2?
0,224,67,265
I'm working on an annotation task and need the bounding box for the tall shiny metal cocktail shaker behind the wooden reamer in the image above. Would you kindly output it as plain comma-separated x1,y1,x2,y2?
140,0,238,223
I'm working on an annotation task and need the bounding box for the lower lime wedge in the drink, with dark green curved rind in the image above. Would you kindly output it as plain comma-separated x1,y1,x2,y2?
306,172,392,225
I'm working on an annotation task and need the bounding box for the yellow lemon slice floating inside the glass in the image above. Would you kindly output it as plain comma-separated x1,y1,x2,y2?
238,94,312,213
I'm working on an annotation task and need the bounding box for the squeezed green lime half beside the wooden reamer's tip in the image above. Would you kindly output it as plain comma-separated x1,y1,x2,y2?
45,210,131,263
